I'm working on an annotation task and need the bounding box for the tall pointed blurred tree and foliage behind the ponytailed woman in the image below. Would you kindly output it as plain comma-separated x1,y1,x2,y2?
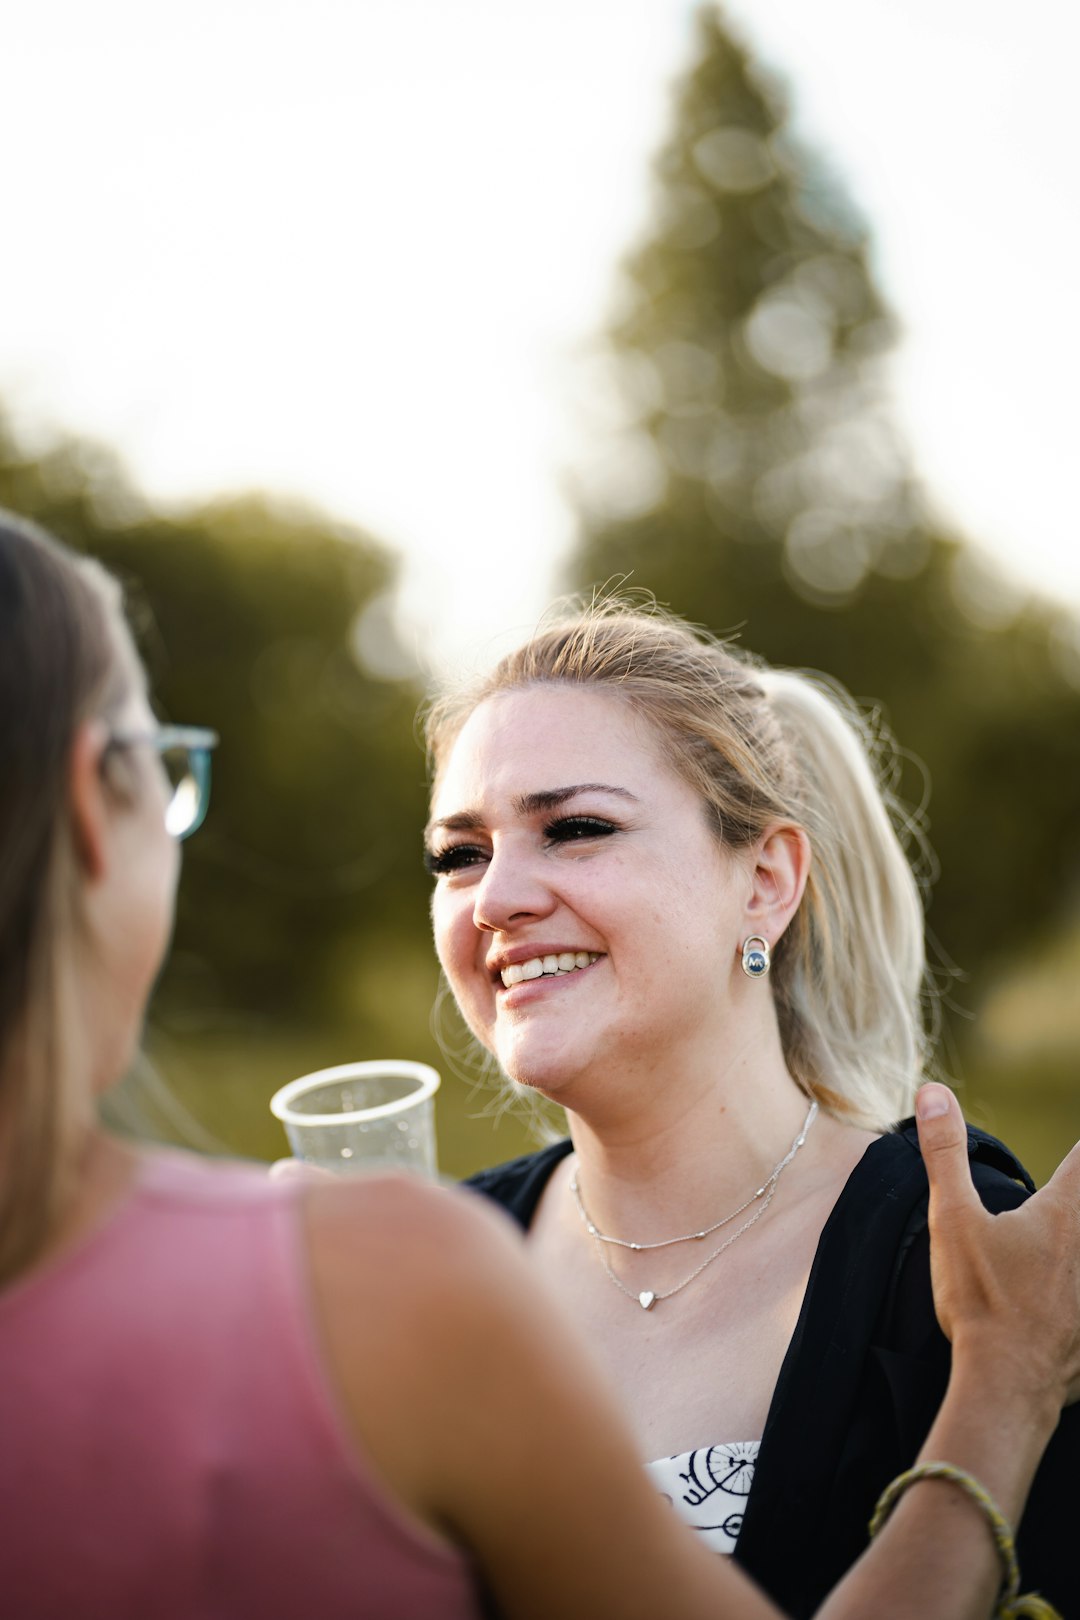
572,6,1080,1034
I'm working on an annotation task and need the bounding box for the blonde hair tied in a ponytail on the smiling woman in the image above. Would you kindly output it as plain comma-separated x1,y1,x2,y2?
426,598,928,1131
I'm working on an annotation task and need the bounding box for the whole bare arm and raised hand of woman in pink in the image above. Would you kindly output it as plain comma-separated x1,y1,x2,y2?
302,1089,1080,1620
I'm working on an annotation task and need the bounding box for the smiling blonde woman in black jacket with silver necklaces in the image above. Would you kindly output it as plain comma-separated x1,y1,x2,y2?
427,603,1080,1615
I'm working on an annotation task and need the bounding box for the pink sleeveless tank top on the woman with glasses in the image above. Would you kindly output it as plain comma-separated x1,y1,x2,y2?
0,1153,479,1620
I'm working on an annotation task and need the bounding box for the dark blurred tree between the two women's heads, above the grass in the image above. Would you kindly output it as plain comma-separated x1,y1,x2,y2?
0,420,434,1025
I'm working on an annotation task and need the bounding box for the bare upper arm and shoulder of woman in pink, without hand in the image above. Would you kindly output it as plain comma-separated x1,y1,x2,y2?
304,1183,777,1620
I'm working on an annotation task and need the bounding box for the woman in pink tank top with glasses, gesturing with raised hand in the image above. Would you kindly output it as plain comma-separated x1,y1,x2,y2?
0,517,1080,1620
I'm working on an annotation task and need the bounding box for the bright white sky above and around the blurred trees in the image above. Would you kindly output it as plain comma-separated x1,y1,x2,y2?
0,0,1080,670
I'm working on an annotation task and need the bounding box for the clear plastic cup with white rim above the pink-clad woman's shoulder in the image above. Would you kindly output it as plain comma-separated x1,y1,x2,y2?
270,1058,439,1179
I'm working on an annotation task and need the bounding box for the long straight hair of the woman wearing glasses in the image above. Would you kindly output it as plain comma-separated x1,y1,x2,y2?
0,514,142,1280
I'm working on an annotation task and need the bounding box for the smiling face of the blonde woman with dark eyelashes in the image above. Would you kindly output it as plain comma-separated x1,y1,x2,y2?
427,684,753,1100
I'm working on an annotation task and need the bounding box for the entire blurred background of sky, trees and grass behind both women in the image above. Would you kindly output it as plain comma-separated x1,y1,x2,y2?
0,0,1080,1178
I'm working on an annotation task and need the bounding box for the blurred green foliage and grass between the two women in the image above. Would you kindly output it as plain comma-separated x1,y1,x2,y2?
0,405,540,1175
